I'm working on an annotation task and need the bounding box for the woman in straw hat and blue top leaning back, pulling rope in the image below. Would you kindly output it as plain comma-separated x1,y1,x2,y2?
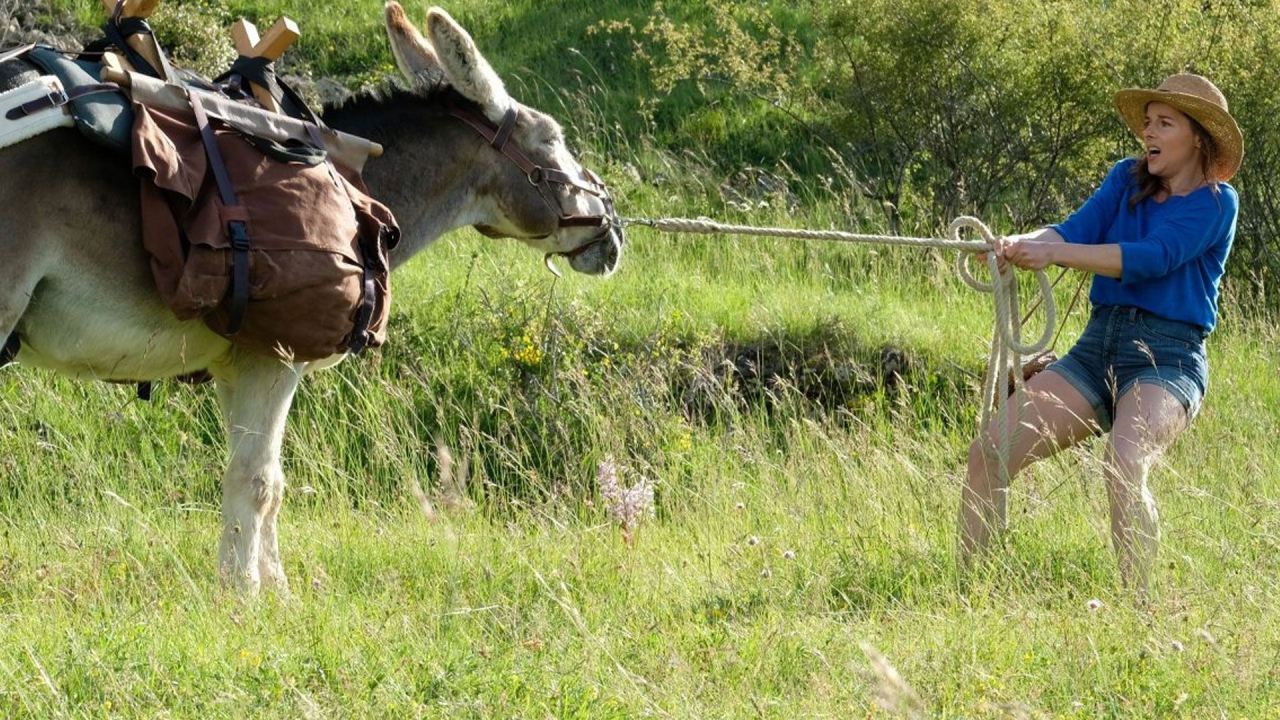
960,74,1244,597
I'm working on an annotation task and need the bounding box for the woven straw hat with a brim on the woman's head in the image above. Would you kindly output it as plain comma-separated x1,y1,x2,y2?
1115,73,1244,181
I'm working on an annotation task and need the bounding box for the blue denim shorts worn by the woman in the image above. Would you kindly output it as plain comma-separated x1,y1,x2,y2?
1047,305,1208,432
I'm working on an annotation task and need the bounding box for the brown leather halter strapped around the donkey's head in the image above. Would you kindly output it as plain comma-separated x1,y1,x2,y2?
449,104,621,263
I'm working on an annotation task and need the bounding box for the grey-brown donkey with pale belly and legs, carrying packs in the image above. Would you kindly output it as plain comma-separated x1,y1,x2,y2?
0,1,623,592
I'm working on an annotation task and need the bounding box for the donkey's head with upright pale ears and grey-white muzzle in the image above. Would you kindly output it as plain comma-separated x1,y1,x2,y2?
385,1,623,274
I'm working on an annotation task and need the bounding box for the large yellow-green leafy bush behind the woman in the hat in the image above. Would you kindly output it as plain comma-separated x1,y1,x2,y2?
614,0,1280,299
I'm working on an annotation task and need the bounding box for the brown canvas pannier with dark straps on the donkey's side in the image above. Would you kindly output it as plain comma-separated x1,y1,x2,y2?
133,96,399,360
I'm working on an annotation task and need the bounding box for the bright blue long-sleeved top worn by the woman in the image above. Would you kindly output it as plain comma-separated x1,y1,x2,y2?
1053,158,1239,331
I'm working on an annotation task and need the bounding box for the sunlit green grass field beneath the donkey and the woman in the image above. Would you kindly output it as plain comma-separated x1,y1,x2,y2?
0,3,1280,720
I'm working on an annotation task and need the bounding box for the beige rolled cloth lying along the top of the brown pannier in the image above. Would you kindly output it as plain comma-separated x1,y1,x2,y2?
119,73,374,173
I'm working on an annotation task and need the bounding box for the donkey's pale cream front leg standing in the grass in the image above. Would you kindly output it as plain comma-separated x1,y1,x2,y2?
211,350,300,592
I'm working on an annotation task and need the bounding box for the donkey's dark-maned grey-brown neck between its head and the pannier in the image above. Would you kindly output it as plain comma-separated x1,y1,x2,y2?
324,91,483,268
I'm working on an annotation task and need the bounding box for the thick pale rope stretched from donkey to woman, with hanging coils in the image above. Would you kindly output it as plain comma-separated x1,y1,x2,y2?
621,217,1057,488
